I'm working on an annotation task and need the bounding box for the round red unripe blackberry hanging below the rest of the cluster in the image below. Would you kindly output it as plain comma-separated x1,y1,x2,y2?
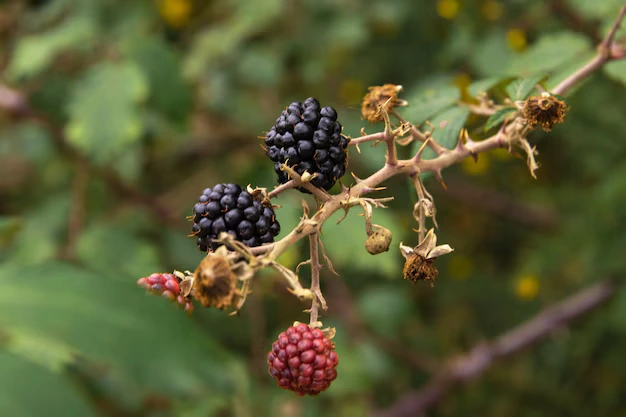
267,323,339,395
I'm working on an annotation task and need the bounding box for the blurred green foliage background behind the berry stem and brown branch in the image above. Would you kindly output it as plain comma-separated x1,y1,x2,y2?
0,0,626,417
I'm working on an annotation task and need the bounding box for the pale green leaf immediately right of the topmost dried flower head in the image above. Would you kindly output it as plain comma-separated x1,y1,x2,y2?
403,86,461,125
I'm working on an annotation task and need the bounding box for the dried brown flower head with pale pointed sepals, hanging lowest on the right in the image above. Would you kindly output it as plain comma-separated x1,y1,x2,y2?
400,229,454,286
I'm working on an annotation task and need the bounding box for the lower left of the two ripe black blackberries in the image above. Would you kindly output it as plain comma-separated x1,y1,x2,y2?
191,184,280,252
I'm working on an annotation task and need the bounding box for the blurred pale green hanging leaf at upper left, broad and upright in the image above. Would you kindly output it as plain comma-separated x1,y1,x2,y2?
65,62,148,163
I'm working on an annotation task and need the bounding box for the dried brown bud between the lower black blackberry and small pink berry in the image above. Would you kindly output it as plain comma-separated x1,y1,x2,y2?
193,253,238,309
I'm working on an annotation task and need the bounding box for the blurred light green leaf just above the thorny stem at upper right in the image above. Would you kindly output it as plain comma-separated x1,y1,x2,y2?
510,32,592,75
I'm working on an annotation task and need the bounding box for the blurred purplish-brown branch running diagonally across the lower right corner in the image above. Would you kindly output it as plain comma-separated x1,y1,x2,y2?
376,280,619,417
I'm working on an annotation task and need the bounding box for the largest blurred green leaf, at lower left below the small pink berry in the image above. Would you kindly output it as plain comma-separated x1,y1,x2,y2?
0,263,232,395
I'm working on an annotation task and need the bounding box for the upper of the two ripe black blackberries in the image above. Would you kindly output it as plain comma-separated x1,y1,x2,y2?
265,97,348,193
